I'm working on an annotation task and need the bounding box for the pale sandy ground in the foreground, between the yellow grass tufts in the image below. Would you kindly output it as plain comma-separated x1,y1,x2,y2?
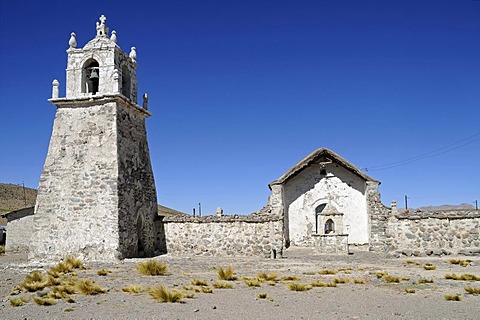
0,249,480,319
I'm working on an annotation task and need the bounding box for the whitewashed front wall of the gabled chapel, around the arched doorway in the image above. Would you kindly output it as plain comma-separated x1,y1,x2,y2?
283,164,369,246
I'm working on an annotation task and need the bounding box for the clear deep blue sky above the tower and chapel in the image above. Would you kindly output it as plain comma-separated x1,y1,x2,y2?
0,0,480,214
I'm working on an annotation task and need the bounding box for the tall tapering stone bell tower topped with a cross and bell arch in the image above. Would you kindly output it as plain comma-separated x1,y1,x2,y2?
29,15,157,261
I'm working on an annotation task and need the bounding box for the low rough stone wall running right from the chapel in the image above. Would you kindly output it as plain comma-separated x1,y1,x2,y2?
386,210,480,256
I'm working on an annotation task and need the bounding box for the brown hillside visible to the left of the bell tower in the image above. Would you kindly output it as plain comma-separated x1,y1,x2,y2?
0,183,37,213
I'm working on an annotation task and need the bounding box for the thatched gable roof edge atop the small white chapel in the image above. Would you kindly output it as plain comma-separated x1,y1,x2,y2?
268,148,379,187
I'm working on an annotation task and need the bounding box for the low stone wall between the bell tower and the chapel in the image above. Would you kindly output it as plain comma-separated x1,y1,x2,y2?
163,215,283,258
